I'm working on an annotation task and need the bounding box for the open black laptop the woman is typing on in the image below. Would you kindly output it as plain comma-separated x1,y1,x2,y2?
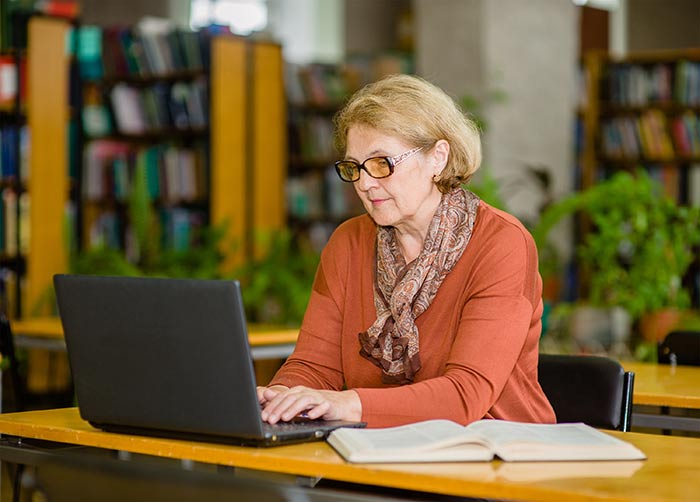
54,274,365,446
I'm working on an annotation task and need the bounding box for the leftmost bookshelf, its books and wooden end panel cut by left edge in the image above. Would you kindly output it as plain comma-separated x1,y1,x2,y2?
0,11,72,317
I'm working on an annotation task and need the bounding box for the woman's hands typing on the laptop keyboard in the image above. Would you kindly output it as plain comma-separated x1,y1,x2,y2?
258,385,362,424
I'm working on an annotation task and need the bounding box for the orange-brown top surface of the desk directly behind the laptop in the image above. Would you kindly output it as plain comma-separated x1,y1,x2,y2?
12,317,299,347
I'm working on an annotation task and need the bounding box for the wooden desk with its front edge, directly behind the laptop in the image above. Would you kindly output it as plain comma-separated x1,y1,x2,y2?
12,317,299,360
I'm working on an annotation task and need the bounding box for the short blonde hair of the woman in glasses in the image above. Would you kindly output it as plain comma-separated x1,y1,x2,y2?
333,75,481,193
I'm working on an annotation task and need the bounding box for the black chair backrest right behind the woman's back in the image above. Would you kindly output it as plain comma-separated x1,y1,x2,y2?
538,354,634,431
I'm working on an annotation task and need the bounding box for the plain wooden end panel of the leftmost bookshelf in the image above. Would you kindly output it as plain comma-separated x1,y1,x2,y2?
22,17,71,316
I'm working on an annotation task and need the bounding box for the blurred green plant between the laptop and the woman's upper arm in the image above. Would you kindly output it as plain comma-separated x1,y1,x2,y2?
233,230,319,326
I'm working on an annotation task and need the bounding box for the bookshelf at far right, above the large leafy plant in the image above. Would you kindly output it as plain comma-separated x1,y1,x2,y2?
577,49,700,308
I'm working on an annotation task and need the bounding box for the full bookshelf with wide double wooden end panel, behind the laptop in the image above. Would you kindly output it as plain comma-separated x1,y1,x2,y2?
78,23,286,271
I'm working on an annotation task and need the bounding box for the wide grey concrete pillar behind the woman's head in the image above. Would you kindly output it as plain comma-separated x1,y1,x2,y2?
414,0,578,229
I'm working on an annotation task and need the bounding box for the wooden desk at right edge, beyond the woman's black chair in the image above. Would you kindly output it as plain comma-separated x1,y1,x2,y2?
622,362,700,431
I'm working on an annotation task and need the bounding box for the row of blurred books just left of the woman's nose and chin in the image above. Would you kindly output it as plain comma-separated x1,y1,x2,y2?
286,166,363,222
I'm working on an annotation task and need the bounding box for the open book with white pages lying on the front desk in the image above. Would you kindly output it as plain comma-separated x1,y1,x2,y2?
328,420,646,462
